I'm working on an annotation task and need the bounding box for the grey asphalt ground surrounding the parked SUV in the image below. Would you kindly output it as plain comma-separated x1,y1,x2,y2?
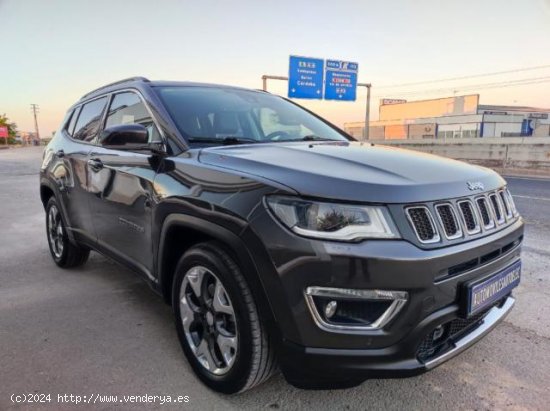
0,148,550,410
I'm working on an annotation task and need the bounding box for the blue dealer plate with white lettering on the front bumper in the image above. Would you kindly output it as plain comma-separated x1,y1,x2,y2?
467,261,521,315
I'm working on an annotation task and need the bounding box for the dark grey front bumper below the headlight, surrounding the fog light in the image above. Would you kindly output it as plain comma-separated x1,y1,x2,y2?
246,208,524,387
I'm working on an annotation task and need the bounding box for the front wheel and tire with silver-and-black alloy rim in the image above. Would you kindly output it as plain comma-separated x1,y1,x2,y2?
172,242,277,394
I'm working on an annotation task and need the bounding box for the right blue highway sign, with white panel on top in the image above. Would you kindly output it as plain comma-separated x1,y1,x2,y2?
325,60,359,101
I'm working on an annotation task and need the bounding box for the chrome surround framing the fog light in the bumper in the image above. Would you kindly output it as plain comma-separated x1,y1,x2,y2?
304,287,409,334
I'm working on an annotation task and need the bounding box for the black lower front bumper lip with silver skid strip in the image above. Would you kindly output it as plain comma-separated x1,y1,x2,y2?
281,296,515,389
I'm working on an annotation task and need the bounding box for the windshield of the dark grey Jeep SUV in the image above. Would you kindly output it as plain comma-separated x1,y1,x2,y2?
158,86,347,144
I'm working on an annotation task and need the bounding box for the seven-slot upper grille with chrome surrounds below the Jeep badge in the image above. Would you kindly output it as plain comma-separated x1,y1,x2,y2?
405,188,518,244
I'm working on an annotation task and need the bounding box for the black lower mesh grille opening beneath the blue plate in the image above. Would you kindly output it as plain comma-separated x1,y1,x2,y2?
416,307,492,362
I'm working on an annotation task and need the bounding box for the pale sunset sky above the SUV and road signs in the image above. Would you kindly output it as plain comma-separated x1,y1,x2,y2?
0,0,550,136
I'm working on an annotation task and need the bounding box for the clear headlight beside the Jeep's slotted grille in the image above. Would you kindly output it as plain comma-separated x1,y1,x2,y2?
267,196,399,241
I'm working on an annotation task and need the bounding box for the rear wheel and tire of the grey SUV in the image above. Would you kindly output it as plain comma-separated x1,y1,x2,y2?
46,196,90,268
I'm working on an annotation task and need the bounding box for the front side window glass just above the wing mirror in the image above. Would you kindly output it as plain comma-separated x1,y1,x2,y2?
105,92,160,142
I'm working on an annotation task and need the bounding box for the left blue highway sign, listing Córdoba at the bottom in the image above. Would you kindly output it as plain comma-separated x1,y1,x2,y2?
288,56,324,99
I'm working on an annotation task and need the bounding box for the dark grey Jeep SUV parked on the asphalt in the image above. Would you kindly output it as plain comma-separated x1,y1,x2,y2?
40,78,523,393
